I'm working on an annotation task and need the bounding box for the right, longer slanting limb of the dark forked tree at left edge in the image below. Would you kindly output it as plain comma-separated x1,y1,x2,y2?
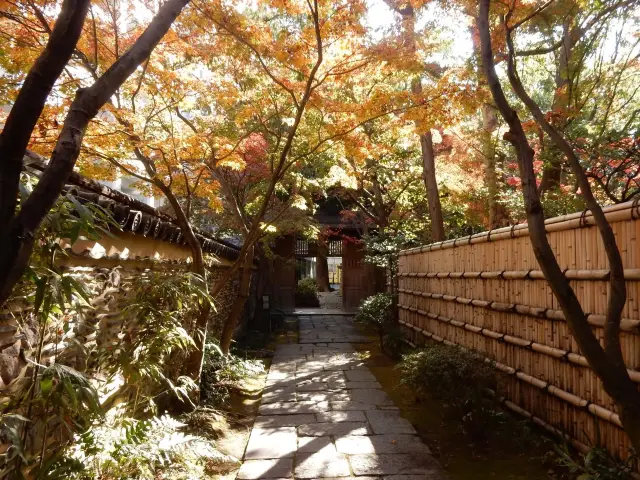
0,0,189,305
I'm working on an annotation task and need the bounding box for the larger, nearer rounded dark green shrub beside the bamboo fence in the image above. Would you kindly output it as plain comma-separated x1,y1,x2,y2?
398,344,500,440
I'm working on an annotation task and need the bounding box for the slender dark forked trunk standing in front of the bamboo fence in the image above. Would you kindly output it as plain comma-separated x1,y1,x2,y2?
478,0,640,451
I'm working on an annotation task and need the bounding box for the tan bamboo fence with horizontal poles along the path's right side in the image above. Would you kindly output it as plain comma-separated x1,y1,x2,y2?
398,201,640,458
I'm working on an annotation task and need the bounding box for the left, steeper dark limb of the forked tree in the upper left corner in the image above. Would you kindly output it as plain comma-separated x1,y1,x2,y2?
0,0,90,232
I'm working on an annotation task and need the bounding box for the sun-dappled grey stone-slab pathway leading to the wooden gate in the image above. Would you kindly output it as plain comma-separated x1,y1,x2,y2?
237,312,446,480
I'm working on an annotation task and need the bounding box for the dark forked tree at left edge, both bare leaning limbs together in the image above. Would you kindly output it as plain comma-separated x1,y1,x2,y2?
0,0,188,303
